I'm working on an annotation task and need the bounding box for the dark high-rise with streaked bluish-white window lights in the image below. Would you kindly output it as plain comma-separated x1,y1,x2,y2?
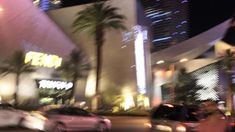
141,0,188,52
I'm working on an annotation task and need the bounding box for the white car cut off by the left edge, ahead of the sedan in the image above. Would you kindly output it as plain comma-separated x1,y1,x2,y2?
0,103,27,127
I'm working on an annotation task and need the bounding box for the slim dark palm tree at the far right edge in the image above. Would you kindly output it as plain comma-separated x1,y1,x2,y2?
222,49,235,112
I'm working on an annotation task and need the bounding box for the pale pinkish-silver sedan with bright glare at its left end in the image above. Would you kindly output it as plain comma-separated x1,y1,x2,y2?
21,106,111,132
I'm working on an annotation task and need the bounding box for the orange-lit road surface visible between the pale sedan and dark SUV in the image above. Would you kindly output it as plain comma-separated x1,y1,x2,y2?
0,116,148,132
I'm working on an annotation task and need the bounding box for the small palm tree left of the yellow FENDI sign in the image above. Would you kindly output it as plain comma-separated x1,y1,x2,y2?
0,50,35,106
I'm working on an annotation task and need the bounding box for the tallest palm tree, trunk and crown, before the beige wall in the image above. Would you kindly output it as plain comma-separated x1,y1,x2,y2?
73,1,126,103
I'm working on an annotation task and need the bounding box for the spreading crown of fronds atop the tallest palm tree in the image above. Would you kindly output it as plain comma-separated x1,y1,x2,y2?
72,1,126,35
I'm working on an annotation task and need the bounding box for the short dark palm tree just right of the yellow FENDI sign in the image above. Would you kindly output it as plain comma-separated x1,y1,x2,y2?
57,50,90,99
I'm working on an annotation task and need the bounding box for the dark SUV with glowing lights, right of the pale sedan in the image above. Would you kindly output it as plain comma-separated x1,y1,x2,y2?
148,103,199,132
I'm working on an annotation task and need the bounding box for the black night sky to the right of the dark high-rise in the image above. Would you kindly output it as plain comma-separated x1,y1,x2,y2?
189,0,235,36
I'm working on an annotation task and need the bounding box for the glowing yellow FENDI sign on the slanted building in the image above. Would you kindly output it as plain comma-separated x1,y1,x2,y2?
24,51,62,68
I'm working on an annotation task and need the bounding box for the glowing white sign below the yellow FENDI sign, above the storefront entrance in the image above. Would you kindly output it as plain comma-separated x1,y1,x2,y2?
36,80,73,90
